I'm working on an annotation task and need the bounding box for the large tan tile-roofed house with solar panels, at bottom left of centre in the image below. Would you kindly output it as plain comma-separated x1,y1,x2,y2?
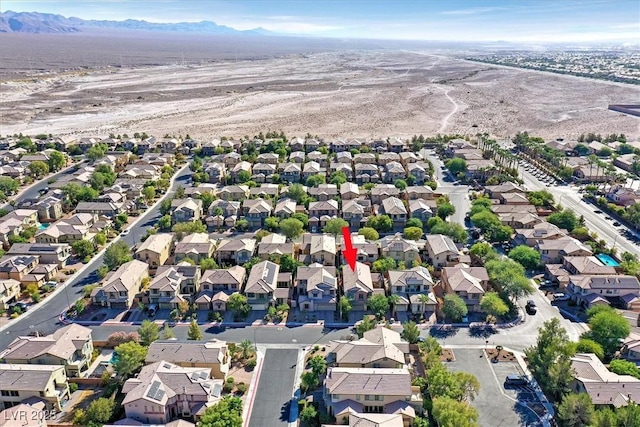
122,360,223,424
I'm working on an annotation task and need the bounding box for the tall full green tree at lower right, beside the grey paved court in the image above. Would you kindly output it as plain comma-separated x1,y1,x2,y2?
525,317,573,399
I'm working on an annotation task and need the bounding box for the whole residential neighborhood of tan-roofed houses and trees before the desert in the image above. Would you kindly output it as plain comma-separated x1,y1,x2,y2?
0,134,640,426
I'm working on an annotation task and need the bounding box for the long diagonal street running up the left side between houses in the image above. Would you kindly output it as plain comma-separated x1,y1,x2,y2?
0,164,191,348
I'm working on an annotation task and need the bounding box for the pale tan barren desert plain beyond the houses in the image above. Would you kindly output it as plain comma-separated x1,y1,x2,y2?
0,49,640,140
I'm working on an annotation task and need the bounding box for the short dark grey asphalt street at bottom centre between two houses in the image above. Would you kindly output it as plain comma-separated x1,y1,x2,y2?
249,349,299,427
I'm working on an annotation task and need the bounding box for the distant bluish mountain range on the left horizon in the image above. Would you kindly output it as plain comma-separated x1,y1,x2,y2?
0,10,271,35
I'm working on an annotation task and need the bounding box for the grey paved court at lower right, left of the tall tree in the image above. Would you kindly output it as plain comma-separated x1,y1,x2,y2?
446,349,538,427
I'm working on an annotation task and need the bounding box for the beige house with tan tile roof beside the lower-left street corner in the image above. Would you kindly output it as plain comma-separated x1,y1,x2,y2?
0,323,93,377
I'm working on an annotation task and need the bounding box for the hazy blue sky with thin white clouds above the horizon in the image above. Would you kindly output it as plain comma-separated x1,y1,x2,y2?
0,0,640,42
